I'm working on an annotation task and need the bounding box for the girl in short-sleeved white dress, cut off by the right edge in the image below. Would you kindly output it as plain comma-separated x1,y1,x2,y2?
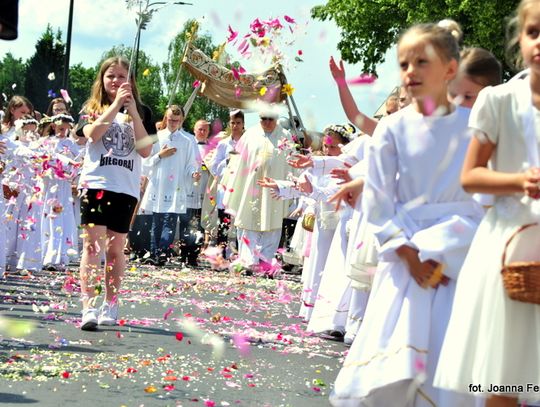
435,0,540,407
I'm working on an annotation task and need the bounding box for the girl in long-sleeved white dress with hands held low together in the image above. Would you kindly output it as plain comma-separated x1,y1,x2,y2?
330,24,482,406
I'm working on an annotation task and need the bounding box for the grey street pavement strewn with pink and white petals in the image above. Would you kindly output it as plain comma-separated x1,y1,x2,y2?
0,265,347,407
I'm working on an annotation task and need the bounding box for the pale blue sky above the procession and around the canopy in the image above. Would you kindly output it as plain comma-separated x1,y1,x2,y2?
0,0,399,130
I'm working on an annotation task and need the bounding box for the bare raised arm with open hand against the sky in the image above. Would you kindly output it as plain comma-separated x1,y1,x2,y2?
330,57,378,136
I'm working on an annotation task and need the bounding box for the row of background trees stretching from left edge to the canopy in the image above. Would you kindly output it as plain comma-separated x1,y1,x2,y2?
0,20,229,130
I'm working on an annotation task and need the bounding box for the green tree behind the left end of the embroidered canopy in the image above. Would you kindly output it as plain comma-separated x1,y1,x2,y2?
159,20,229,131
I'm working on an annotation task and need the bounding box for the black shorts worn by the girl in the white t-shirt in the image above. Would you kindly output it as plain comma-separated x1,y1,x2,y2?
81,189,137,233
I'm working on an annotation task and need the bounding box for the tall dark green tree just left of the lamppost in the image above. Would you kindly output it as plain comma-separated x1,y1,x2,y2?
23,25,65,112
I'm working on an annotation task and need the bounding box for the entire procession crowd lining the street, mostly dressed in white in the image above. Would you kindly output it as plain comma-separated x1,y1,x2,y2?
0,0,540,407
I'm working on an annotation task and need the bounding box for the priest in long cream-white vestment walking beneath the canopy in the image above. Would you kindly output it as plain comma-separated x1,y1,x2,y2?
223,110,294,269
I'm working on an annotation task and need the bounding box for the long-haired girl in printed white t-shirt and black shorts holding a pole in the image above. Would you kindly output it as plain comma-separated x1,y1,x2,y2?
78,57,152,330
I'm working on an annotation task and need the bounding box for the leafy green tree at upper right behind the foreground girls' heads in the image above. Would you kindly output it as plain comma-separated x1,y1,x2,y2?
311,0,519,75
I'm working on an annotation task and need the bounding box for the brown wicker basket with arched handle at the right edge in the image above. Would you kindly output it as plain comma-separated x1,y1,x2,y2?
501,223,540,305
